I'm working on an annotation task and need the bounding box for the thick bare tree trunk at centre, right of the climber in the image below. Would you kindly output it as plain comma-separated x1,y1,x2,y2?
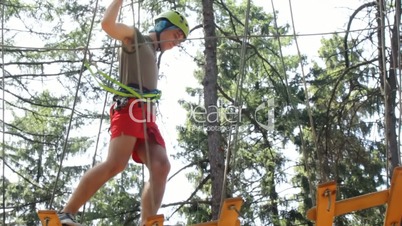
202,0,224,219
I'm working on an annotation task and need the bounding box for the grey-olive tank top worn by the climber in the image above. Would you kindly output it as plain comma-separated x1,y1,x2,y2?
119,28,159,90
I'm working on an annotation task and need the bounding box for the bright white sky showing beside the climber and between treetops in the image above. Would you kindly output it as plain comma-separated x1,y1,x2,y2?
0,0,368,223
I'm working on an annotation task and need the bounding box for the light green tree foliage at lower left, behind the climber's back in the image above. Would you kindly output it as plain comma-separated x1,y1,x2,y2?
5,91,91,225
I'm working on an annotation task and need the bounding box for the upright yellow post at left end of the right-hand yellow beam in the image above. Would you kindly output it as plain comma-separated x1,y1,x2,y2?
316,181,336,226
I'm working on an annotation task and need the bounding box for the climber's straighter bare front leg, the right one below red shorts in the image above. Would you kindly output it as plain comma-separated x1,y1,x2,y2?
138,143,170,224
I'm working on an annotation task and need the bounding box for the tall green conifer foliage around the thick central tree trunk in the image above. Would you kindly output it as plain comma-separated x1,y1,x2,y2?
178,2,297,225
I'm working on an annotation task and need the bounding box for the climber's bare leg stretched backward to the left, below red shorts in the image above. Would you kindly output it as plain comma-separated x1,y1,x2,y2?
62,135,137,214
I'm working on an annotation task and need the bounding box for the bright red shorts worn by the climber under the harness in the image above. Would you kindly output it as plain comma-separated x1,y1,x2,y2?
110,99,165,163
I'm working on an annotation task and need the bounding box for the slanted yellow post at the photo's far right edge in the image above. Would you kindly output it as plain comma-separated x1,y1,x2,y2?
384,167,402,226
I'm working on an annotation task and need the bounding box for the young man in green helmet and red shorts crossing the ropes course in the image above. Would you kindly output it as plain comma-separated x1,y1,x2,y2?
59,0,189,225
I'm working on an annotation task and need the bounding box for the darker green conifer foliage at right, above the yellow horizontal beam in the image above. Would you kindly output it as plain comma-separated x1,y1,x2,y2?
295,31,386,225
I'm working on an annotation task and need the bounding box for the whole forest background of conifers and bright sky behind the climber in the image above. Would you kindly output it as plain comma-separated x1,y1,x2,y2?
1,0,401,226
